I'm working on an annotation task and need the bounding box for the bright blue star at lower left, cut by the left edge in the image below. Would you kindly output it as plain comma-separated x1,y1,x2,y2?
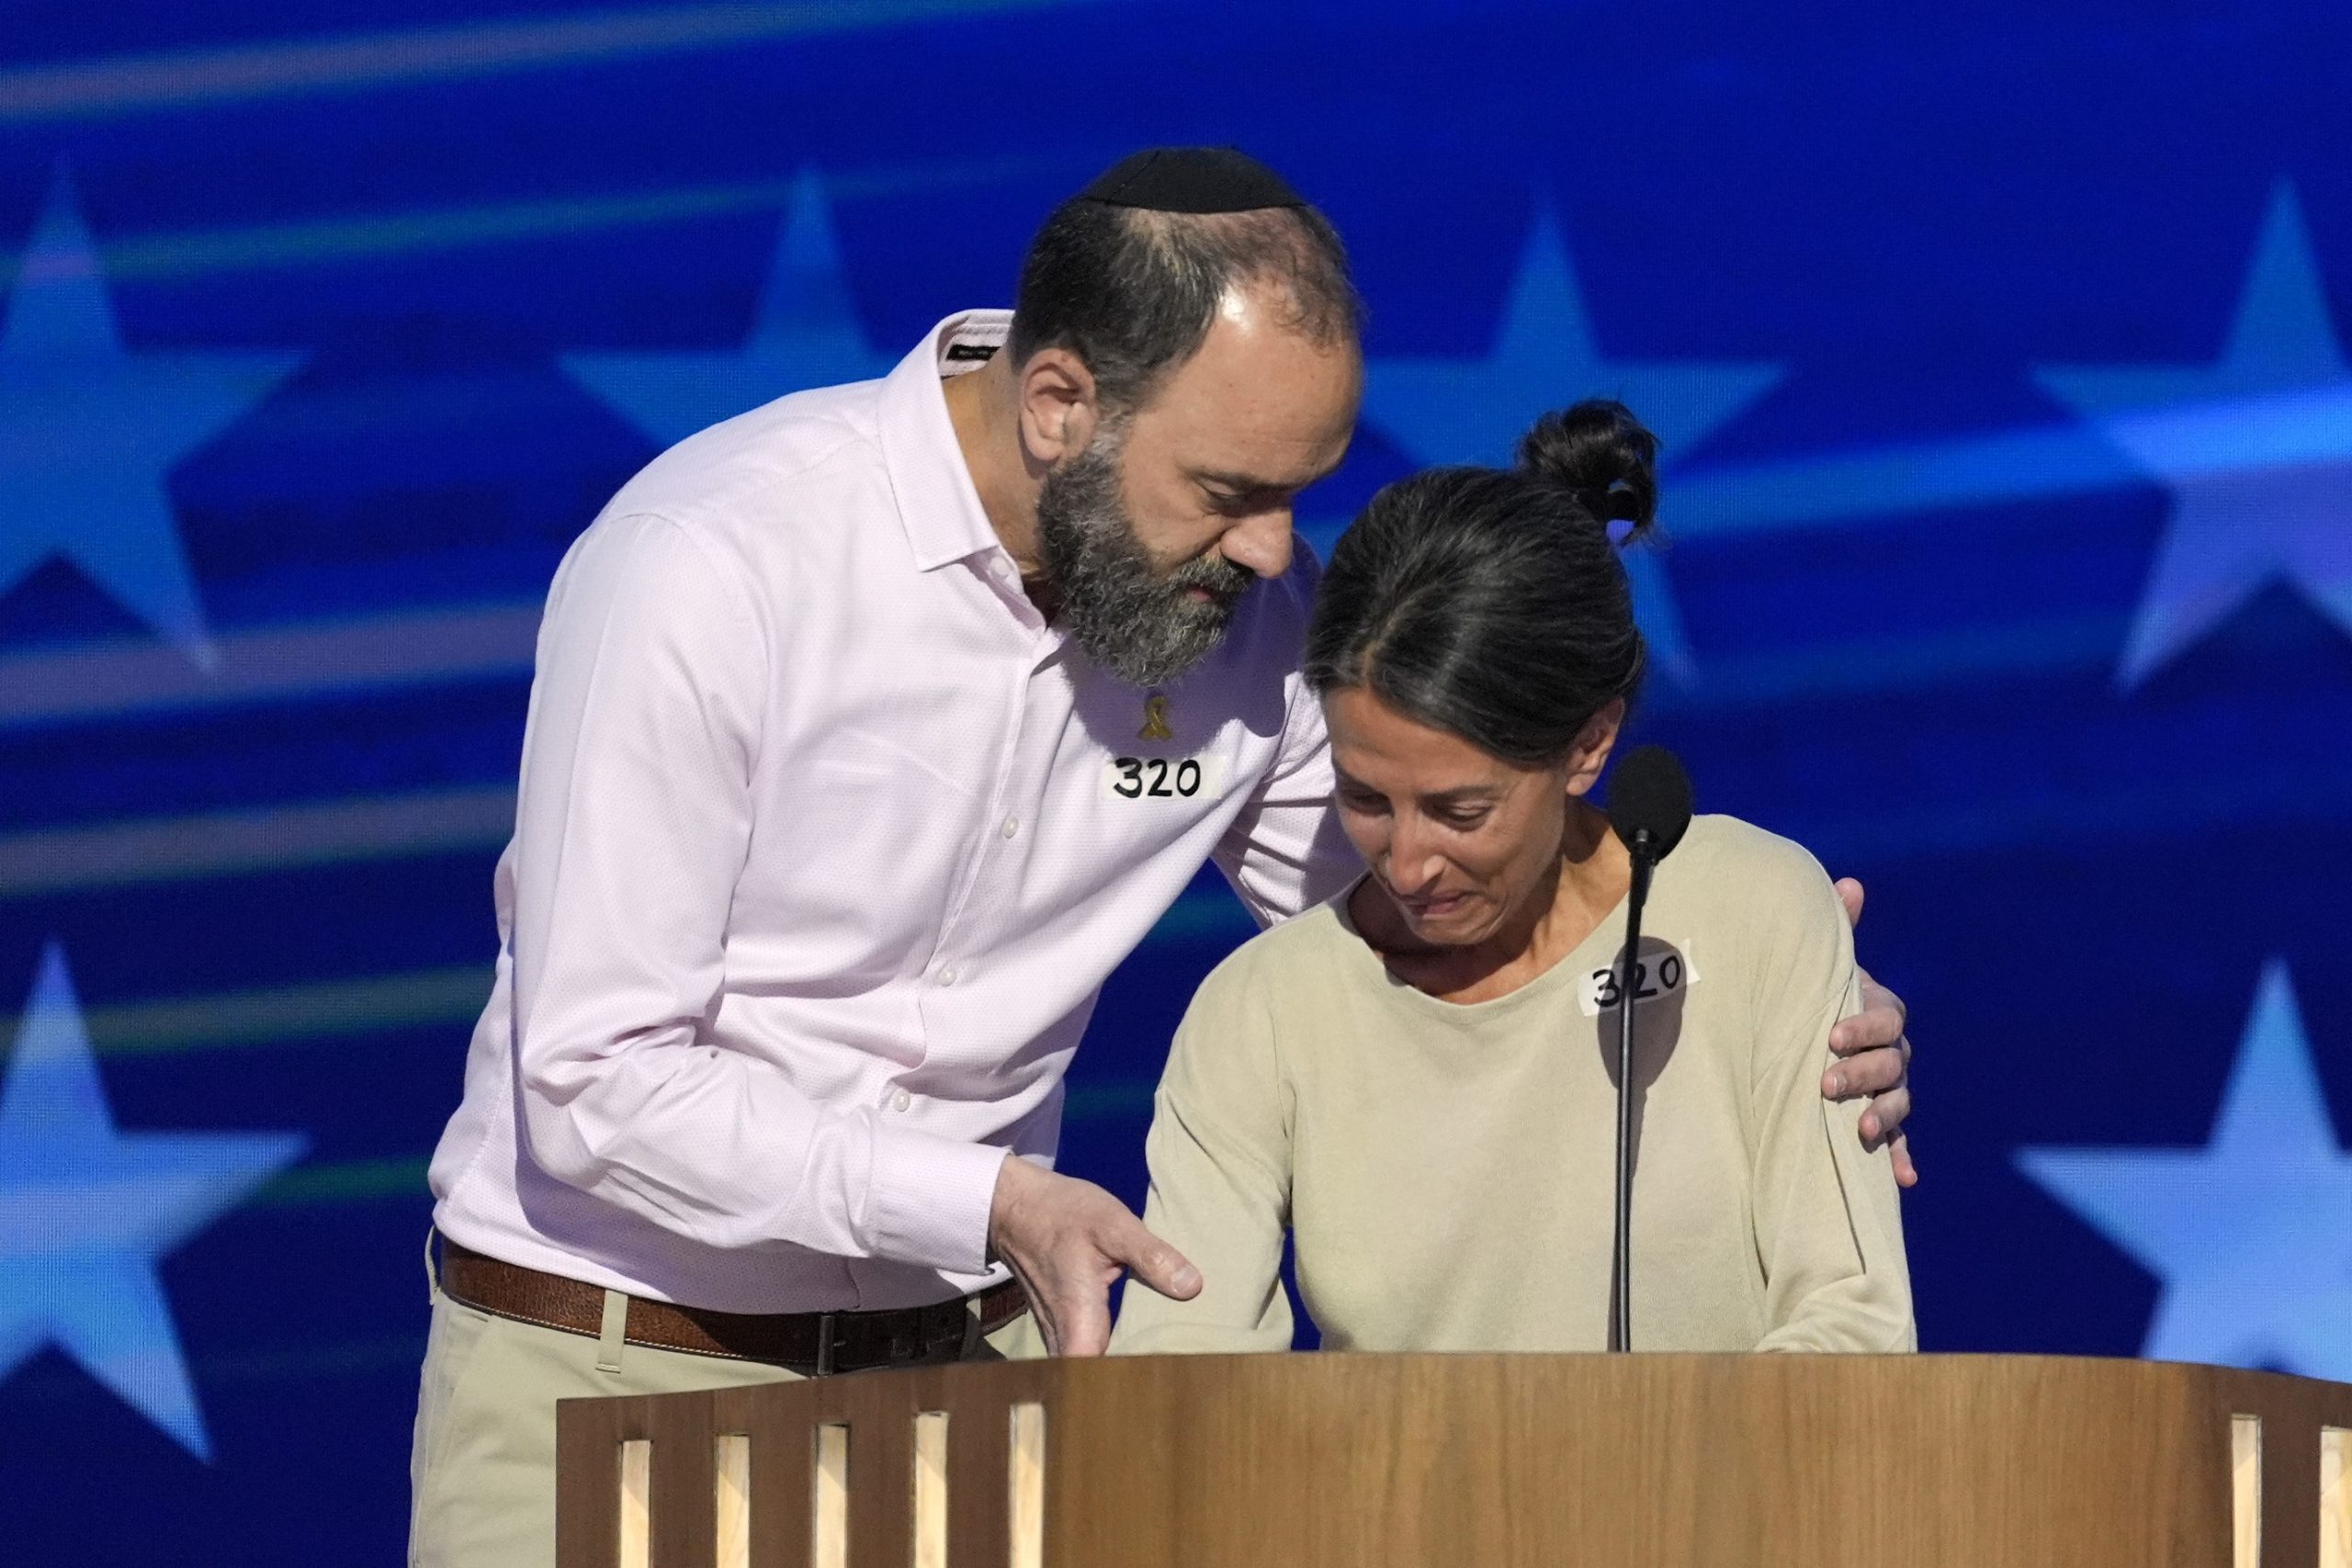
0,942,303,1458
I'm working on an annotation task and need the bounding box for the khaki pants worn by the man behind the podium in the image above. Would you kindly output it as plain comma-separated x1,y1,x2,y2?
409,1286,1045,1568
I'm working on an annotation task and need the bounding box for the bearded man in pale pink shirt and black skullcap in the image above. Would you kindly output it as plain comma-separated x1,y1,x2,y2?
412,148,1907,1565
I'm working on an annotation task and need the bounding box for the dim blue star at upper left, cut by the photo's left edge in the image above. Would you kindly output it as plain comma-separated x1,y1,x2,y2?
0,167,308,670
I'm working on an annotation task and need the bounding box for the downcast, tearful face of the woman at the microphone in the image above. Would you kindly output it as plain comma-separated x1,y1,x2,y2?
1324,689,1623,947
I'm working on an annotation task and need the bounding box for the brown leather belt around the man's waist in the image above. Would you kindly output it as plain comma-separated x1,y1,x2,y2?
440,1236,1028,1378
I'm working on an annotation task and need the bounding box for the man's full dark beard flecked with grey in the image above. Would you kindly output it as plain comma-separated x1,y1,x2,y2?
1037,425,1256,686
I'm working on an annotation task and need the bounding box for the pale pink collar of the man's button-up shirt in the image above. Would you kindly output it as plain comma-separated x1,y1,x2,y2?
882,310,1013,571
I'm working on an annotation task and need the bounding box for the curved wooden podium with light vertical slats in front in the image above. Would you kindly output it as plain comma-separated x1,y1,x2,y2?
555,1354,2352,1568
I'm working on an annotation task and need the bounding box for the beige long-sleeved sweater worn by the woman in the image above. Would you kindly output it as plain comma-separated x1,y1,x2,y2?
1113,816,1917,1352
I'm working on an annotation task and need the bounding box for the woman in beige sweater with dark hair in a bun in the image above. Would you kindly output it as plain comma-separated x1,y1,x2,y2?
1113,402,1917,1352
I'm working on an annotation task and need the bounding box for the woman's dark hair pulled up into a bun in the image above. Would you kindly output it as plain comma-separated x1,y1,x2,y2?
1306,400,1658,766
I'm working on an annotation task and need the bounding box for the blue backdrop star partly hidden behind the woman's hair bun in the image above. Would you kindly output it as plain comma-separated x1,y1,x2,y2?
1364,209,1782,684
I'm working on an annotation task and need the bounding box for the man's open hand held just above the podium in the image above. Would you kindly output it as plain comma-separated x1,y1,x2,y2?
988,1156,1200,1357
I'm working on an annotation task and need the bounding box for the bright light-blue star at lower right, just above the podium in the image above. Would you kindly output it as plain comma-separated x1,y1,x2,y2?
2018,959,2352,1378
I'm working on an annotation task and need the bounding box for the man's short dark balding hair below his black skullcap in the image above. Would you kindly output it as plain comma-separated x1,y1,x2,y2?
1007,197,1362,413
